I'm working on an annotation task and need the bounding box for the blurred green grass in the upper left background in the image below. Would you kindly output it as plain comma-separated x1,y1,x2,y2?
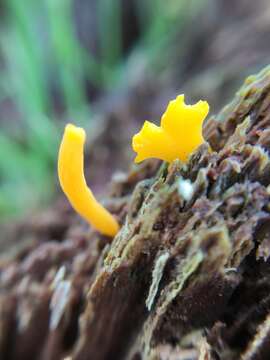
0,0,205,219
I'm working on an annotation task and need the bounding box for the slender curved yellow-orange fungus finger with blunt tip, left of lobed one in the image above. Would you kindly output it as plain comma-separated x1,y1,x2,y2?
58,124,119,236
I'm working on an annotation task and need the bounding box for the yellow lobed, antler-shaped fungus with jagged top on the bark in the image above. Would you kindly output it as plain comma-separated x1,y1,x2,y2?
132,95,209,163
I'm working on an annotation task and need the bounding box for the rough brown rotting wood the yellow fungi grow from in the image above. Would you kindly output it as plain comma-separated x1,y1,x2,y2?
0,68,270,360
